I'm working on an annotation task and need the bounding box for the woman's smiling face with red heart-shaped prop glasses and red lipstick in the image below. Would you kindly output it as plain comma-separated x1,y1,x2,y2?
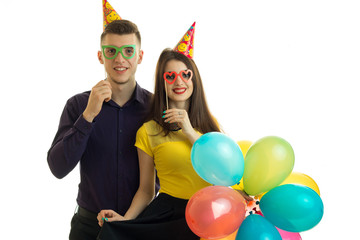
164,59,193,104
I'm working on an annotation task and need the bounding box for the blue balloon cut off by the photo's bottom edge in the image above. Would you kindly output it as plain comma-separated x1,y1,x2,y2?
235,214,282,240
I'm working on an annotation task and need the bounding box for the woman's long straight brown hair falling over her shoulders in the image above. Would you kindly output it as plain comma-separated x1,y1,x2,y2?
147,48,220,136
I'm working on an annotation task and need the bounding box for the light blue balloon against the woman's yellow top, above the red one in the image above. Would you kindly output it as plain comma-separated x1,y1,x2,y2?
191,132,244,186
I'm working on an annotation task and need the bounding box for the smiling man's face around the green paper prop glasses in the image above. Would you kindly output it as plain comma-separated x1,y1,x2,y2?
98,33,143,84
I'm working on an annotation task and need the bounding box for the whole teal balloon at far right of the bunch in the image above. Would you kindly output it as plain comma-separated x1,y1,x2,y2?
260,184,324,232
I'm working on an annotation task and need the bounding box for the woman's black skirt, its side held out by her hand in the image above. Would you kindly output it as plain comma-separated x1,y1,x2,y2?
97,193,200,240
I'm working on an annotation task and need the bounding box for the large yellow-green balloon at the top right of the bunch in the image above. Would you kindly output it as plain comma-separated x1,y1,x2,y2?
243,136,295,196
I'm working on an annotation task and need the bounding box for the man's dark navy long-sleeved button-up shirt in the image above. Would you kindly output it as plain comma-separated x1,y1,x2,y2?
47,84,151,215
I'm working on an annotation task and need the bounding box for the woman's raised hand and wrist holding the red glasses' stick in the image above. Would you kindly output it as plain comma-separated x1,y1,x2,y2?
163,108,200,143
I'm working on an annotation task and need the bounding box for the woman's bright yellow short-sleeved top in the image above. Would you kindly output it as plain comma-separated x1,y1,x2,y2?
135,121,211,199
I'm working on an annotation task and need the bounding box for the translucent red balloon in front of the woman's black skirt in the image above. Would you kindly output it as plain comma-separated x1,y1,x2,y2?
185,186,246,239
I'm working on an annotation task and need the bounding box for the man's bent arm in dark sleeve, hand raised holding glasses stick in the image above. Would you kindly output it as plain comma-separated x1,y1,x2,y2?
48,80,112,178
